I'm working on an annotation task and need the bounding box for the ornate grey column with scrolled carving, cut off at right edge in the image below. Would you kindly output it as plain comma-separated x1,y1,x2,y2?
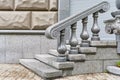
104,0,120,55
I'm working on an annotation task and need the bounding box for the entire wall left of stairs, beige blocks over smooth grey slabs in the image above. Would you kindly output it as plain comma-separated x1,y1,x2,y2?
0,0,58,63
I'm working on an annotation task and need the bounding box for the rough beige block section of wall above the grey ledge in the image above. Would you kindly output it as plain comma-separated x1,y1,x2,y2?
0,0,58,30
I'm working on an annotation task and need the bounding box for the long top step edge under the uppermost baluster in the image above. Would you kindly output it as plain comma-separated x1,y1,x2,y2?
90,40,117,47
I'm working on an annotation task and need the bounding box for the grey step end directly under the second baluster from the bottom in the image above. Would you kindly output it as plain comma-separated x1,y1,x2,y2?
68,54,86,61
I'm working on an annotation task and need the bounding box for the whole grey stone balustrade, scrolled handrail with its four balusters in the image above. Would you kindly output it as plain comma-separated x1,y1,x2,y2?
45,1,109,62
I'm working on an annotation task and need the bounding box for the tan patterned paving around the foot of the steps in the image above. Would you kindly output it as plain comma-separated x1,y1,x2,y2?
0,64,120,80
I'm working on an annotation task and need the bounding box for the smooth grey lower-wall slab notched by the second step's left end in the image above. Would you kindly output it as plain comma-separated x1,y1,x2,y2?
22,35,41,58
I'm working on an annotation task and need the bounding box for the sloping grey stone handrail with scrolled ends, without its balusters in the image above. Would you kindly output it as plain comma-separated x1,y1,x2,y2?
45,1,109,39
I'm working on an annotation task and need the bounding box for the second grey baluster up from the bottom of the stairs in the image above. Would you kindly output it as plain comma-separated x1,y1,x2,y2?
69,23,78,54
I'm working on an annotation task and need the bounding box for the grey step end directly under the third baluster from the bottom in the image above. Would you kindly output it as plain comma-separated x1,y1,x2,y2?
79,47,97,54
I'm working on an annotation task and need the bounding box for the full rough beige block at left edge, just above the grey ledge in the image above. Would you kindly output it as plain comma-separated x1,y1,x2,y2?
0,11,30,30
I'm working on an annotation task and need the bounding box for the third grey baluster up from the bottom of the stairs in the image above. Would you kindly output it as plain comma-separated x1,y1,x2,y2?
80,17,90,47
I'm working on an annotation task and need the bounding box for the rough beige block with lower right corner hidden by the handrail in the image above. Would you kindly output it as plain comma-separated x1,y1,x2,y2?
32,12,57,30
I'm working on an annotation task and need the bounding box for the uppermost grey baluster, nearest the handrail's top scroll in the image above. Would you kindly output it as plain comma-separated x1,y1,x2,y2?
91,12,100,41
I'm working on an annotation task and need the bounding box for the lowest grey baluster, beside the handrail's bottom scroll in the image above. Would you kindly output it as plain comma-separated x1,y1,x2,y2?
57,29,67,62
